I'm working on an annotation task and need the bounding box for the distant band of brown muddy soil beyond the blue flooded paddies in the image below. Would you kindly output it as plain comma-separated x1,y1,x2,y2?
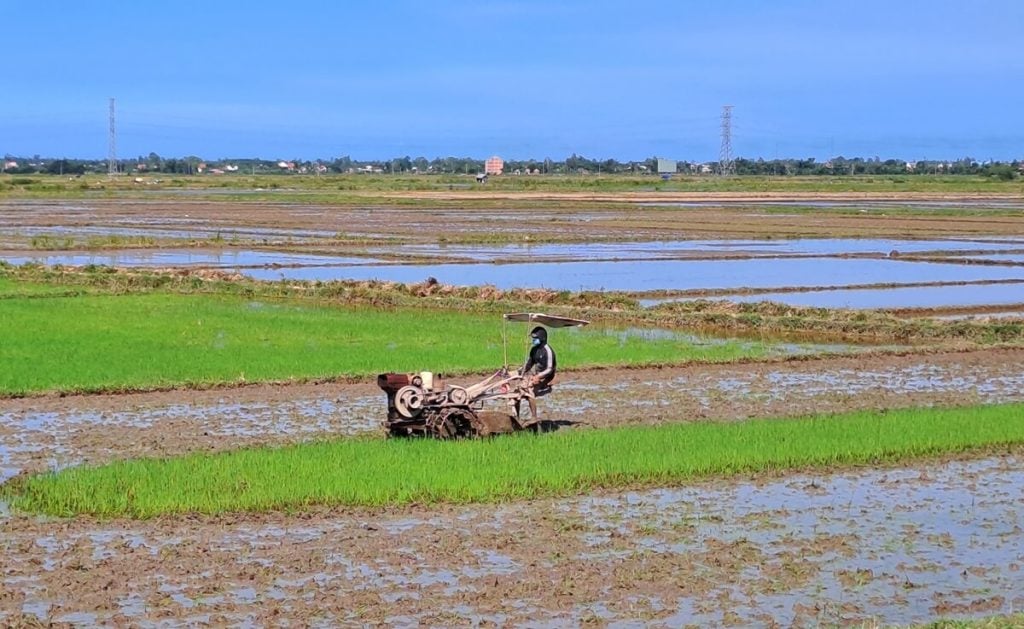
0,198,1024,250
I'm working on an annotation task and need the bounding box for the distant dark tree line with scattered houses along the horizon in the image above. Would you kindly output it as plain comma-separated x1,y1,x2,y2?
3,153,1024,179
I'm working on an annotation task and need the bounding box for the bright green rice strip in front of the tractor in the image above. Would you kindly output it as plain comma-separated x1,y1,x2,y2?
8,404,1024,517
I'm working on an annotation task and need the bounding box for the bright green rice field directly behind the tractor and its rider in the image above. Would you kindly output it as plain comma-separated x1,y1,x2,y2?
0,286,766,395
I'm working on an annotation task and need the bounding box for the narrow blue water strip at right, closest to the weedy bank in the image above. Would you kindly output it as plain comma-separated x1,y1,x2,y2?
640,282,1024,308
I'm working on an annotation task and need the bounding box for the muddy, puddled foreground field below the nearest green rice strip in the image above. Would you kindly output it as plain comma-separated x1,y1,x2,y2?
0,456,1024,627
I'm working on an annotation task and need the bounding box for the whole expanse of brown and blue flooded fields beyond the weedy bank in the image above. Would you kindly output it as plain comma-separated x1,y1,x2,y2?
0,191,1024,307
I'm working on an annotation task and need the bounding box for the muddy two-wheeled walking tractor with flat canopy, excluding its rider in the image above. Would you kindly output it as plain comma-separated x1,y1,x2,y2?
377,312,589,438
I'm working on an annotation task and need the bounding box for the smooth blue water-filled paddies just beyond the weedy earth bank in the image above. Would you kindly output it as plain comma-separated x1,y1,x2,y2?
0,239,1024,308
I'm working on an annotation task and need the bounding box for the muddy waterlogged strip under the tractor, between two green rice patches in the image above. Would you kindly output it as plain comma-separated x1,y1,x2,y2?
0,350,1024,481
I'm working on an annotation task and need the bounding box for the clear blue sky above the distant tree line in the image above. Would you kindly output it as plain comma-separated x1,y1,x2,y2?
0,0,1024,161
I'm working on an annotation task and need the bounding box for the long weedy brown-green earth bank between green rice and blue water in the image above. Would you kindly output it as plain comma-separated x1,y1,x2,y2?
0,261,1024,354
